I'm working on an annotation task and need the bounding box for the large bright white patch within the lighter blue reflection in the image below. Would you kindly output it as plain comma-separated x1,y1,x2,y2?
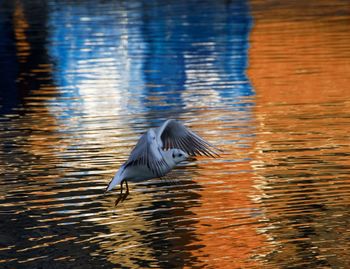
77,16,132,117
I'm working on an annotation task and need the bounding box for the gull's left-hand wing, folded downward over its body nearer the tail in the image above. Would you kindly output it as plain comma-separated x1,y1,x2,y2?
125,129,168,176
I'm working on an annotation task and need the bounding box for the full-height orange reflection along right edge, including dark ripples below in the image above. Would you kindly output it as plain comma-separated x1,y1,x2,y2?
248,0,350,268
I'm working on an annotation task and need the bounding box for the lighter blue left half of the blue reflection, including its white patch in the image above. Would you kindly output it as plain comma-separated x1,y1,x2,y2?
49,6,144,121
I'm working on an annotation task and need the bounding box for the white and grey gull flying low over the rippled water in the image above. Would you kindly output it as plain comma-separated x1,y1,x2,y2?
106,119,220,206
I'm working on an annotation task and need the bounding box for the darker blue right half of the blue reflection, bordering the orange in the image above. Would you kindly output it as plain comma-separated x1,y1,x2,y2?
142,1,253,110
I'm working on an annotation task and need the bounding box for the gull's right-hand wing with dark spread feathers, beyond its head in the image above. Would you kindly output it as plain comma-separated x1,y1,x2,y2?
157,120,220,158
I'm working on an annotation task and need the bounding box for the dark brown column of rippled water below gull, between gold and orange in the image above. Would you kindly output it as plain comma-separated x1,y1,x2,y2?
136,166,202,268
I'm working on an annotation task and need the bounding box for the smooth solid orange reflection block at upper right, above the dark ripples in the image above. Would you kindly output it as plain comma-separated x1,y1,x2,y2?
248,0,350,103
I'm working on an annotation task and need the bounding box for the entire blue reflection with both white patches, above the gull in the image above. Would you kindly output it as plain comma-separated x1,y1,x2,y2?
48,1,254,120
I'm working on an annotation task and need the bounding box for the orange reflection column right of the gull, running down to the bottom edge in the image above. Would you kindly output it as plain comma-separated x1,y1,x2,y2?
185,111,268,268
